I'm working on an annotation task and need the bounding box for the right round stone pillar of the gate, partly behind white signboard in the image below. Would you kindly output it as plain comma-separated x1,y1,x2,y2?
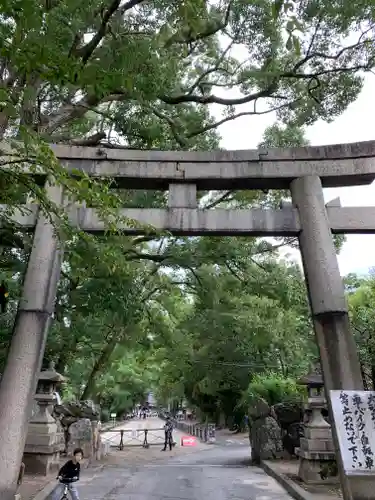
290,176,366,500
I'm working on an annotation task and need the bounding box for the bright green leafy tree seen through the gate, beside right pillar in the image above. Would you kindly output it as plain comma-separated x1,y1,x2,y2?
151,234,316,423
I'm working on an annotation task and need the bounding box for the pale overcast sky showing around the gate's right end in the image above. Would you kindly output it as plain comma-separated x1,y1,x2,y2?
215,74,375,276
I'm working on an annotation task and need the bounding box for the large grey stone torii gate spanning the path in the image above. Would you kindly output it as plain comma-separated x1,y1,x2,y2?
0,141,375,500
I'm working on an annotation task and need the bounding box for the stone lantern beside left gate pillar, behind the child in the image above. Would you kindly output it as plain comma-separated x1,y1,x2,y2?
23,363,65,475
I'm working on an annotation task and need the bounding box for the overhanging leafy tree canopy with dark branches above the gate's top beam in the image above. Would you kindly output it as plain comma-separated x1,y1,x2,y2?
0,0,374,156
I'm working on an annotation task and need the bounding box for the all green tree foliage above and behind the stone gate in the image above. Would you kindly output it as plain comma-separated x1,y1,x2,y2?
0,0,375,423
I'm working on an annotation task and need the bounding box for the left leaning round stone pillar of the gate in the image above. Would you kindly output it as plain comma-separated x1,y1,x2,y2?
0,184,63,500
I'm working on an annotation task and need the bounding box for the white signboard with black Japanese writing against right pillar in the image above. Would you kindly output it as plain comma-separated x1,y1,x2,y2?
329,391,375,475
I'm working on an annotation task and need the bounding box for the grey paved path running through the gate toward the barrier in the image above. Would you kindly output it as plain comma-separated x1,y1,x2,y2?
72,419,291,500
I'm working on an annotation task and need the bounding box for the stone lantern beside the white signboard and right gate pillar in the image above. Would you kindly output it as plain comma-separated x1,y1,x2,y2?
296,365,339,484
